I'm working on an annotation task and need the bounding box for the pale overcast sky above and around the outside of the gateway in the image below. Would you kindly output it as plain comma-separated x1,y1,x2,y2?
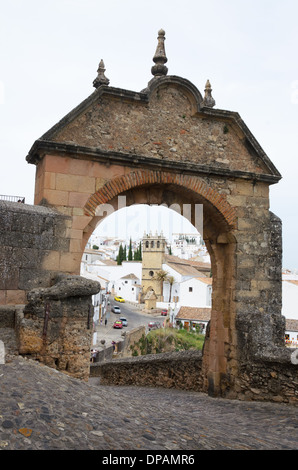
0,0,298,268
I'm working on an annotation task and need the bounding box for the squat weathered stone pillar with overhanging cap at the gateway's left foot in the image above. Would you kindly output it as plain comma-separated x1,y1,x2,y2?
16,274,100,380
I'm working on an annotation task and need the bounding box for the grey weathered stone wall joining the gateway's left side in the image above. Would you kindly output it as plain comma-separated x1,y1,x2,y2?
0,201,69,305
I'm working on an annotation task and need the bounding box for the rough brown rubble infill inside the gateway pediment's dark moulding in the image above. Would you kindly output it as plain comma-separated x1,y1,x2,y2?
53,81,270,177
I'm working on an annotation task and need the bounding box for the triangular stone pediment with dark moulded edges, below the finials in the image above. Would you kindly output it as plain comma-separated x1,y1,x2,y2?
27,76,281,183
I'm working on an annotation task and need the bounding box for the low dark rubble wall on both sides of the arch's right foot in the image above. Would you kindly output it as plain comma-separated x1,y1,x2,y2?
90,351,298,405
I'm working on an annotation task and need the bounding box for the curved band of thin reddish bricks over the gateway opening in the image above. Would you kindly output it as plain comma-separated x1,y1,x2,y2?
84,170,236,228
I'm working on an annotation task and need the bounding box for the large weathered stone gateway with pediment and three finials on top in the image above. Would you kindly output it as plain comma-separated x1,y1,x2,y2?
27,30,294,396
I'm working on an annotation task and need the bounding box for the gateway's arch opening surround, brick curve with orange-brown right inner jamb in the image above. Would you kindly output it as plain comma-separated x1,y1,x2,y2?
84,170,237,395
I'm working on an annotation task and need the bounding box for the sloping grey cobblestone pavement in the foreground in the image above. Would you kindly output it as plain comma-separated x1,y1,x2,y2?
0,357,298,452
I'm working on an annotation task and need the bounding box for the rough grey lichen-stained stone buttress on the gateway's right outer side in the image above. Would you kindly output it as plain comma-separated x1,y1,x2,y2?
236,212,290,364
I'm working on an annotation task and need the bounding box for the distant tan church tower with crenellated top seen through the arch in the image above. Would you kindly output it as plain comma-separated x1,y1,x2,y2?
142,232,166,302
